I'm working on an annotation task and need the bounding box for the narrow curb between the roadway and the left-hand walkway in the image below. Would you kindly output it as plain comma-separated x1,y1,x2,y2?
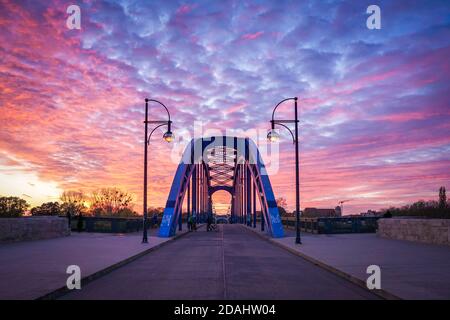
34,225,203,300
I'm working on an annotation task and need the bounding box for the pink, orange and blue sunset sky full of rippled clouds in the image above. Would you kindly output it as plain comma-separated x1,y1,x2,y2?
0,0,450,214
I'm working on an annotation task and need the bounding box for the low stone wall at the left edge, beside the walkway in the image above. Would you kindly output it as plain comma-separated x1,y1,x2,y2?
0,217,70,242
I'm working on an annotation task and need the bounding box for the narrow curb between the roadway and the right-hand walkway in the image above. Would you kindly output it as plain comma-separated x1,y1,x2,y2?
243,226,402,300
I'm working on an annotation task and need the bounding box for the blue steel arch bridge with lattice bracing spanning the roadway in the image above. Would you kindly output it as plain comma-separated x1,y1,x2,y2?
159,136,284,238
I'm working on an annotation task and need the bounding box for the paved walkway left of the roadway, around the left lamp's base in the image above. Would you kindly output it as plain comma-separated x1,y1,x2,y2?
0,226,187,299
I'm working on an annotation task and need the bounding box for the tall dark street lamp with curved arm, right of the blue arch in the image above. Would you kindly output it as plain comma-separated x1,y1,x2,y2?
267,97,302,244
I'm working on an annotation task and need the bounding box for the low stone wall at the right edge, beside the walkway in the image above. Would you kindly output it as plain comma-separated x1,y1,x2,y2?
377,218,450,245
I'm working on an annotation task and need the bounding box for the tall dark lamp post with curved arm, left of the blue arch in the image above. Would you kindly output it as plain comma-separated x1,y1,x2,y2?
142,98,174,243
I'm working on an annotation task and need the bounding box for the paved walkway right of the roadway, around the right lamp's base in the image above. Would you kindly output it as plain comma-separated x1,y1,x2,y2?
253,225,450,299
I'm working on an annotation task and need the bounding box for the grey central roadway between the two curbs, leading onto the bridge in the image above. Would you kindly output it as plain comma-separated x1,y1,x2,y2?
62,225,377,299
